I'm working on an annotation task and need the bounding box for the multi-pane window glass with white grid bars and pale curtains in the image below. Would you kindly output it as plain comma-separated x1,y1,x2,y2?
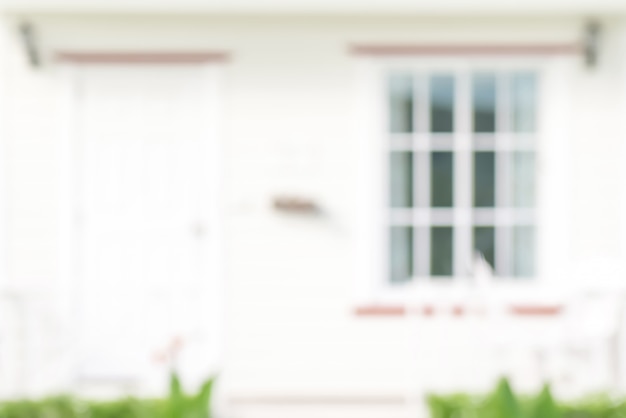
384,70,539,283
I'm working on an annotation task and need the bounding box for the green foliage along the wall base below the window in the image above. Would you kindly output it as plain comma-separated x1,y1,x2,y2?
428,379,626,418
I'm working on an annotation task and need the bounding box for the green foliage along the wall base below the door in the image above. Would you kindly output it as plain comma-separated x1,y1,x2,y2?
0,374,214,418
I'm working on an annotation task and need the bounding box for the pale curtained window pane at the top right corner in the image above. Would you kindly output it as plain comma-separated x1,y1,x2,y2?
511,73,537,132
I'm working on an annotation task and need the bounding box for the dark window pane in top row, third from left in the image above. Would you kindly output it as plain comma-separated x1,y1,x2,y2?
472,74,496,133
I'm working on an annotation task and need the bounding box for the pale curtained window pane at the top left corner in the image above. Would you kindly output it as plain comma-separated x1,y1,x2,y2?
389,74,413,133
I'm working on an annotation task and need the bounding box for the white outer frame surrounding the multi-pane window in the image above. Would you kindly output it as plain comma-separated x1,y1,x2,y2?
355,55,578,304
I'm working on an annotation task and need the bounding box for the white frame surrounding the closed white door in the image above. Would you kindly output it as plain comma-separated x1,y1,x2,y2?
57,52,228,389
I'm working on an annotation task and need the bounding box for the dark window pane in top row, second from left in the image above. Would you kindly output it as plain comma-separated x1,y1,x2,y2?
430,75,454,132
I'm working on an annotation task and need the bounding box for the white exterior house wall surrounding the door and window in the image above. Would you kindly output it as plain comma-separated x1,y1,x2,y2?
2,15,626,412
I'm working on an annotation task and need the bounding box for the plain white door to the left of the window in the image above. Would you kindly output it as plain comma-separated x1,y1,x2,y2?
73,65,220,387
